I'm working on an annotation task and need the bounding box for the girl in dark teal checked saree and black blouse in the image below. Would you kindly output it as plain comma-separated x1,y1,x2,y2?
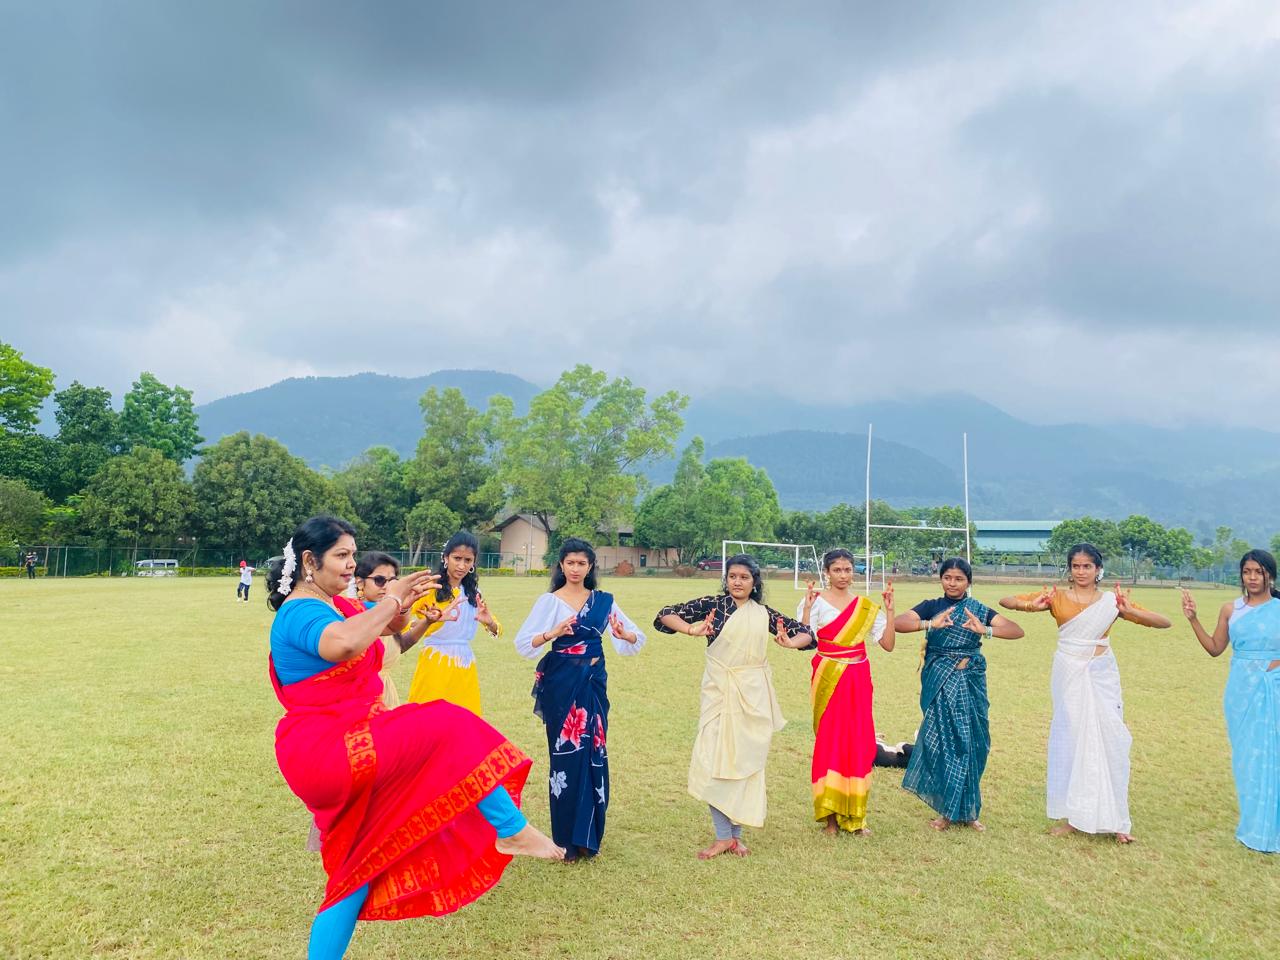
893,557,1023,831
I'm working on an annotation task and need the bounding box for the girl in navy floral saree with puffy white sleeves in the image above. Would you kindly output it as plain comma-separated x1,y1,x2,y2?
516,539,645,860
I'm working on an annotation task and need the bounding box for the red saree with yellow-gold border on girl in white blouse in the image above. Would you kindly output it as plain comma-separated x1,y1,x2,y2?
809,596,879,831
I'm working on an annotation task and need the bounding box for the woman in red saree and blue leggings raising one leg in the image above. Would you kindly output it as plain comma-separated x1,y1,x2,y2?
268,517,564,960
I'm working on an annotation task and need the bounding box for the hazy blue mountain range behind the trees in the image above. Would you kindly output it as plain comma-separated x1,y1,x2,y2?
197,370,1280,544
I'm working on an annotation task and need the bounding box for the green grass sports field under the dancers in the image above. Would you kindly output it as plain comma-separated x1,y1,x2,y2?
0,579,1280,960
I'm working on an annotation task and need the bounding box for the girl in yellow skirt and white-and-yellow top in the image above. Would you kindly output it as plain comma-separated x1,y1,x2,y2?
408,530,502,717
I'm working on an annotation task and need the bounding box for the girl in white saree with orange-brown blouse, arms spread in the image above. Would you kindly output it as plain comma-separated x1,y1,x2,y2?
1000,544,1170,844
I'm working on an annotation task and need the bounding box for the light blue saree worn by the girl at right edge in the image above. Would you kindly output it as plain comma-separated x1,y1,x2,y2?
1222,599,1280,852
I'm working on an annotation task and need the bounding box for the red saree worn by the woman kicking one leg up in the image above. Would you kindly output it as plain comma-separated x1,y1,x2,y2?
270,640,531,920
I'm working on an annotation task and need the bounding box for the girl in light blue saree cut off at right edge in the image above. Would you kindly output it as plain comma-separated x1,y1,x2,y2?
1183,550,1280,854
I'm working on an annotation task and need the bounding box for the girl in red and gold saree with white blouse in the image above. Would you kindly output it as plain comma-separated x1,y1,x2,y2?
796,549,893,836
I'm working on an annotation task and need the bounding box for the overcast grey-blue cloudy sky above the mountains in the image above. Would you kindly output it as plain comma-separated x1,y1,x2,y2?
0,0,1280,429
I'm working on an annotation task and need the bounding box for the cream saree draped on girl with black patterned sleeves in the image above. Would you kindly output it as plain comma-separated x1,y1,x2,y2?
689,600,786,827
